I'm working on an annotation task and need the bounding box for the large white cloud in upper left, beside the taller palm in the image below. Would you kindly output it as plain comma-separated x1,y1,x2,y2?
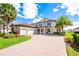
13,3,38,19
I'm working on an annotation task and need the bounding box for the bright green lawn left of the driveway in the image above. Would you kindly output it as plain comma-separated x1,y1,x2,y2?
0,36,30,49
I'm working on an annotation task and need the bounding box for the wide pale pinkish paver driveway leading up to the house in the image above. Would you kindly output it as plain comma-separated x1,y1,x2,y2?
0,35,67,56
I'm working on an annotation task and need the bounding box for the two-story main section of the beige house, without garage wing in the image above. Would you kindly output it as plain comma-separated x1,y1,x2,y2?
32,18,56,34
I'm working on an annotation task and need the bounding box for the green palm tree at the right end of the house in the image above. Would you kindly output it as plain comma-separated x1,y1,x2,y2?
56,15,72,32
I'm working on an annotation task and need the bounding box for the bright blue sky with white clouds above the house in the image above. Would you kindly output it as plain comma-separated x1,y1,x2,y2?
12,3,79,23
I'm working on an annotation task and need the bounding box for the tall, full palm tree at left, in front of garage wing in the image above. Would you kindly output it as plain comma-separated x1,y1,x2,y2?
0,3,17,33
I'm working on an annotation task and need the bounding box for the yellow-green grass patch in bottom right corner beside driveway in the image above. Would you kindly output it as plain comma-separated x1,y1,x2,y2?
66,46,79,56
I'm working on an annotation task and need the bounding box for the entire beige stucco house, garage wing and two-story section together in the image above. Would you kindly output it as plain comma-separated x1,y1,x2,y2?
0,18,56,35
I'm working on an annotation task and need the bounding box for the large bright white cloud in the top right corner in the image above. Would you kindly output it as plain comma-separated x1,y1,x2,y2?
61,1,79,16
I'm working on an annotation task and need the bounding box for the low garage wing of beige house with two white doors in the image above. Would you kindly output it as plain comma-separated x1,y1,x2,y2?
11,24,34,35
